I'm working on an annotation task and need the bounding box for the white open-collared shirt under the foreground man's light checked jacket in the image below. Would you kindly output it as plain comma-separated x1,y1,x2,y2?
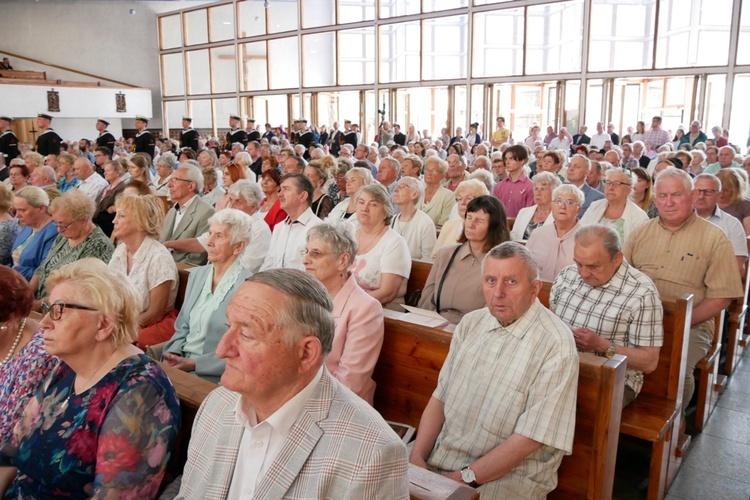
227,366,323,500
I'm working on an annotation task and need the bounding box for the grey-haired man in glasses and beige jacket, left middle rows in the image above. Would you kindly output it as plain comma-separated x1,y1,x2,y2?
159,164,214,266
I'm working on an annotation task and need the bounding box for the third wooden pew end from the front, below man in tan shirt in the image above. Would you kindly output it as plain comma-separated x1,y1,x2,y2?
686,311,726,431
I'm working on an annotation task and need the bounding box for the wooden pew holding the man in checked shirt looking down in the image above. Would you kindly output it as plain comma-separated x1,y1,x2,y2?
539,283,693,499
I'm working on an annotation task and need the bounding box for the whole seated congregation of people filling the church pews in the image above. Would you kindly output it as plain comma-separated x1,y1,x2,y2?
0,113,750,499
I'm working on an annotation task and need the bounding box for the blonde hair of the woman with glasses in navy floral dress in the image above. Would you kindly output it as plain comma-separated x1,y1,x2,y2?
47,258,140,348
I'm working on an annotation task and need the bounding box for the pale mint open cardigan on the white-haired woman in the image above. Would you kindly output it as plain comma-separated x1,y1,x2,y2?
164,264,253,384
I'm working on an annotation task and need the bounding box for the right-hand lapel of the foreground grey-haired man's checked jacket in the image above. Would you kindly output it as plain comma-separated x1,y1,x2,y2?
254,368,333,498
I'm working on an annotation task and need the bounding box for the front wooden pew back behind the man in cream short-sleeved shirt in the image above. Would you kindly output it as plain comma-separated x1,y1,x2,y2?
373,311,626,499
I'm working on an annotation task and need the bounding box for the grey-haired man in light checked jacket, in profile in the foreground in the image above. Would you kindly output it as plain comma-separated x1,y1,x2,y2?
173,269,409,499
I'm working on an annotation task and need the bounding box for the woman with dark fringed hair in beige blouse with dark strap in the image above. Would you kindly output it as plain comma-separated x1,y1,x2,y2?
419,195,510,324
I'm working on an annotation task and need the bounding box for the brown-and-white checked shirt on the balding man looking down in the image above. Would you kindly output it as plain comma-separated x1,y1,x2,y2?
549,261,664,394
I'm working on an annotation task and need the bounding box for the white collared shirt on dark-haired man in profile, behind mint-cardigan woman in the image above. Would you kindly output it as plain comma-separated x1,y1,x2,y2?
260,207,323,271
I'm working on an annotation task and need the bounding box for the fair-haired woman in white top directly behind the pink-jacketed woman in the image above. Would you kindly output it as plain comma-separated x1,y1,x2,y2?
351,184,411,309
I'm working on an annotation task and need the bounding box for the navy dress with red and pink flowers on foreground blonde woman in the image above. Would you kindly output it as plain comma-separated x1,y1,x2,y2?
3,354,179,500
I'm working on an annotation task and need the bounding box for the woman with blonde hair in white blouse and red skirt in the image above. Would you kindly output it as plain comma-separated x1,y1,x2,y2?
109,194,178,349
